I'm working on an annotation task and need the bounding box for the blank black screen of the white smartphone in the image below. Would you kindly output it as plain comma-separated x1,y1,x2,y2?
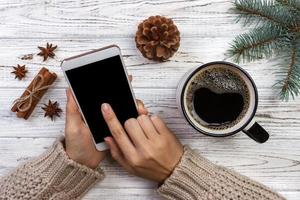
66,55,138,143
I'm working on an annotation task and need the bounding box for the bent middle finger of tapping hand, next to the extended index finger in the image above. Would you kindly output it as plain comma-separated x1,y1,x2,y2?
124,118,147,147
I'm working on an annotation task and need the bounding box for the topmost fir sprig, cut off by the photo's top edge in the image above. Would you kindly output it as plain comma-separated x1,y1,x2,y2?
234,0,294,29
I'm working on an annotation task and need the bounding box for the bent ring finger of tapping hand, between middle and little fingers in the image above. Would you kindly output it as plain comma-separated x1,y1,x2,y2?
137,115,158,140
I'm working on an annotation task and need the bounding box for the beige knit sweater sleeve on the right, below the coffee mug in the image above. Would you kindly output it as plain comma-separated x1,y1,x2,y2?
158,146,284,200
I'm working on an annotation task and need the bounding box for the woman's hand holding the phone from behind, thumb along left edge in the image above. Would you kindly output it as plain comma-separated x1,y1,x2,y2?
65,89,148,169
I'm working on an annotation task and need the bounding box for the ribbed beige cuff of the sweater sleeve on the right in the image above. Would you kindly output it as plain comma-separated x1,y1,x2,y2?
157,146,215,199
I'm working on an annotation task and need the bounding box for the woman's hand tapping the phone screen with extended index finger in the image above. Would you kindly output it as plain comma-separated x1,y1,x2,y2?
101,103,183,183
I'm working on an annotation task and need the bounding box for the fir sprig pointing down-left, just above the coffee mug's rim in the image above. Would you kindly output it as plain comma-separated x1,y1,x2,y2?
227,26,286,62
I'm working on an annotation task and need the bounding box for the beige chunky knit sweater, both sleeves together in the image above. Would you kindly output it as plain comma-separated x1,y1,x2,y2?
0,140,284,200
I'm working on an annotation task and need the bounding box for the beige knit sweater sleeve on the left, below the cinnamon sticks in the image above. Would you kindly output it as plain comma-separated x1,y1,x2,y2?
0,139,104,200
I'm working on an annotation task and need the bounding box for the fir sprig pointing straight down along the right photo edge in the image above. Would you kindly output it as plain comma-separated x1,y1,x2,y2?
275,40,300,101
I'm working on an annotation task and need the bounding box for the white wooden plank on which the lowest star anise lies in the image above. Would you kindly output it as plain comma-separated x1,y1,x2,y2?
0,88,300,140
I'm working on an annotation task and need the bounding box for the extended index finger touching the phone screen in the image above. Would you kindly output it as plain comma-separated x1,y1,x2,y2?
101,103,135,155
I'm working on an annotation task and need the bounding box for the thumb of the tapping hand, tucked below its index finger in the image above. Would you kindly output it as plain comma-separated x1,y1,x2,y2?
104,137,130,171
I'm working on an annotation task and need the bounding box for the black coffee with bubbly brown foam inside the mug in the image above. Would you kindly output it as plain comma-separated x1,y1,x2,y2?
186,64,249,129
